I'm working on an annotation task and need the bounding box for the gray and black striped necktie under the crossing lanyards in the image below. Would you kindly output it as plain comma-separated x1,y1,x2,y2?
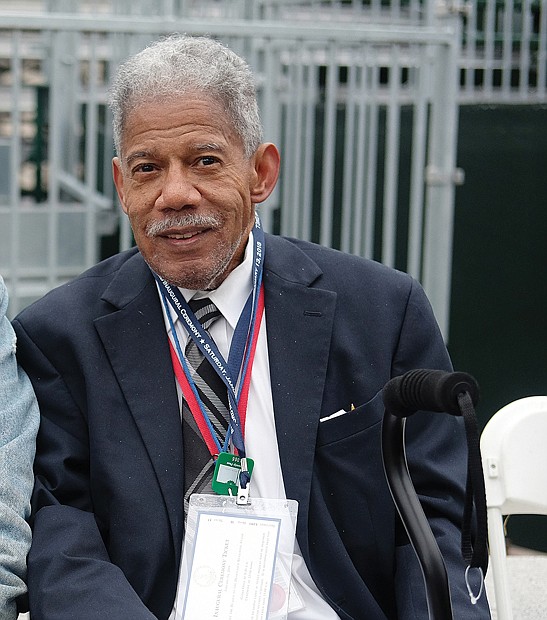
182,298,229,514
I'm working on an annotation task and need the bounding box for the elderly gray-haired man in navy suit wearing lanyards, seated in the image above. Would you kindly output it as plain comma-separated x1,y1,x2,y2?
15,36,489,620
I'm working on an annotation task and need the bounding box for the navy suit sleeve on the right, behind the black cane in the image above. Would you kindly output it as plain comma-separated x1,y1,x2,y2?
392,283,490,620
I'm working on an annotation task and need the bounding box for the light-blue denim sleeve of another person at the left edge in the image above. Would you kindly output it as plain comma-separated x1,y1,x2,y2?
0,276,39,620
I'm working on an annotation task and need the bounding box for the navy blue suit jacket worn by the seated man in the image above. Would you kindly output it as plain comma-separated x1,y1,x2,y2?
14,236,489,620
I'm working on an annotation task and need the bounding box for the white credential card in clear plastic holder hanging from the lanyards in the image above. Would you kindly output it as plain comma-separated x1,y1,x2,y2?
175,495,297,620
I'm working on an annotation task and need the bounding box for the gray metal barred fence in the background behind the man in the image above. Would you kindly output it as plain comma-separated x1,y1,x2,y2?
0,0,547,333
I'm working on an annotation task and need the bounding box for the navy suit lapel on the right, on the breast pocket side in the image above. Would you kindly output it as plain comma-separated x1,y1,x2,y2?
264,236,336,558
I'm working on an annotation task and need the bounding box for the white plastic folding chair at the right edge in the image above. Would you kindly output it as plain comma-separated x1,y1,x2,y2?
480,396,547,620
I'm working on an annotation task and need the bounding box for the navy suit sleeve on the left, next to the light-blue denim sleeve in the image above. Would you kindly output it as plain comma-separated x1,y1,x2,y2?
14,319,155,620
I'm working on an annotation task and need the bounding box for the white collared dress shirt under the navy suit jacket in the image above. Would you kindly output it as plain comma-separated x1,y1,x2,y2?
162,233,339,620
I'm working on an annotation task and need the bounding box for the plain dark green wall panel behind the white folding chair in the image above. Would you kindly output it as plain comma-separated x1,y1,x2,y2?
449,106,547,551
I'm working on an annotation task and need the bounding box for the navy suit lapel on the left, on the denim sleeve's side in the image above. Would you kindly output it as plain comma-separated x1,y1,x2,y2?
95,254,183,561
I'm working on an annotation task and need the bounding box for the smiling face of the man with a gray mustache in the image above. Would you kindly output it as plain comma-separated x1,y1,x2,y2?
113,96,257,290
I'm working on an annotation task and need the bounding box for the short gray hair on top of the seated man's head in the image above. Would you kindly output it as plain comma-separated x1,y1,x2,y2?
109,34,262,157
